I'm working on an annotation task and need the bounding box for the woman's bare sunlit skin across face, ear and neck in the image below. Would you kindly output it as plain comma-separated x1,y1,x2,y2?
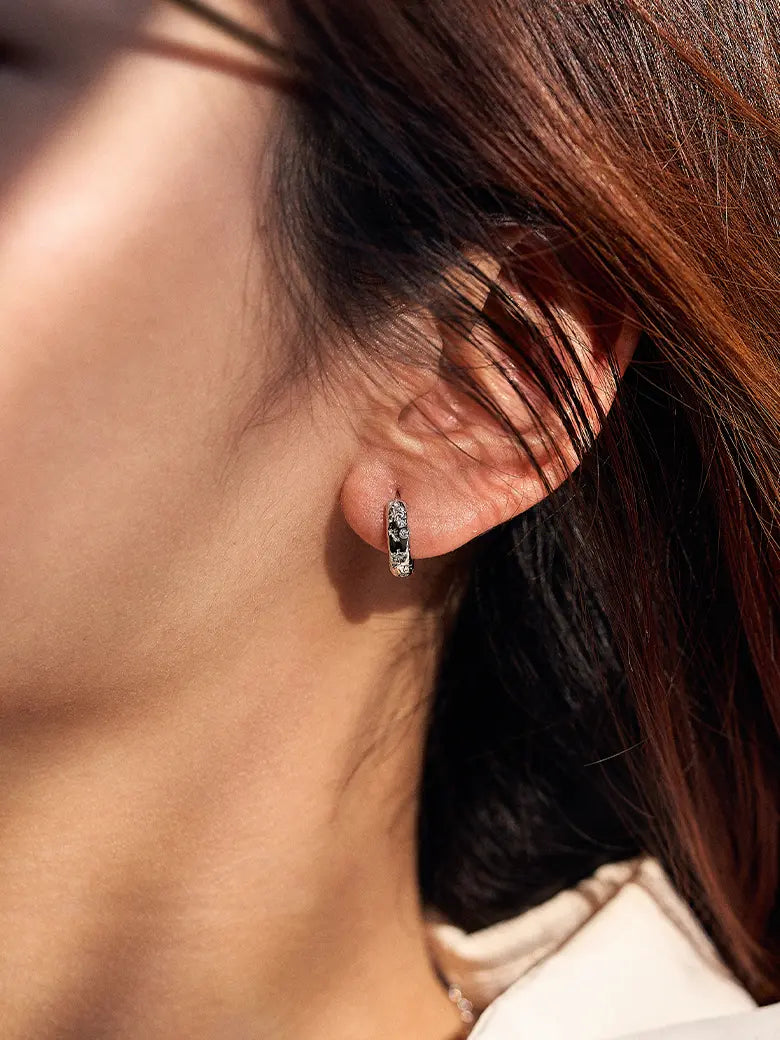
0,0,635,1040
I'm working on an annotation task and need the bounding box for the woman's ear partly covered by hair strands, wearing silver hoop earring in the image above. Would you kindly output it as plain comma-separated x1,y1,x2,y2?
341,231,641,560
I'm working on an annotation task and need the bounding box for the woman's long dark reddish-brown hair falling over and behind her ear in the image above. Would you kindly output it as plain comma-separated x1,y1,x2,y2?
173,0,780,1003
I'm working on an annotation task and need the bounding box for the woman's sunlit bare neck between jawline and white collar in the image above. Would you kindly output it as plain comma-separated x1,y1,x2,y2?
0,561,467,1040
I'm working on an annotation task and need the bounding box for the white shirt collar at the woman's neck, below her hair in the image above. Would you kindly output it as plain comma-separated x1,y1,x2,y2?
426,857,780,1040
